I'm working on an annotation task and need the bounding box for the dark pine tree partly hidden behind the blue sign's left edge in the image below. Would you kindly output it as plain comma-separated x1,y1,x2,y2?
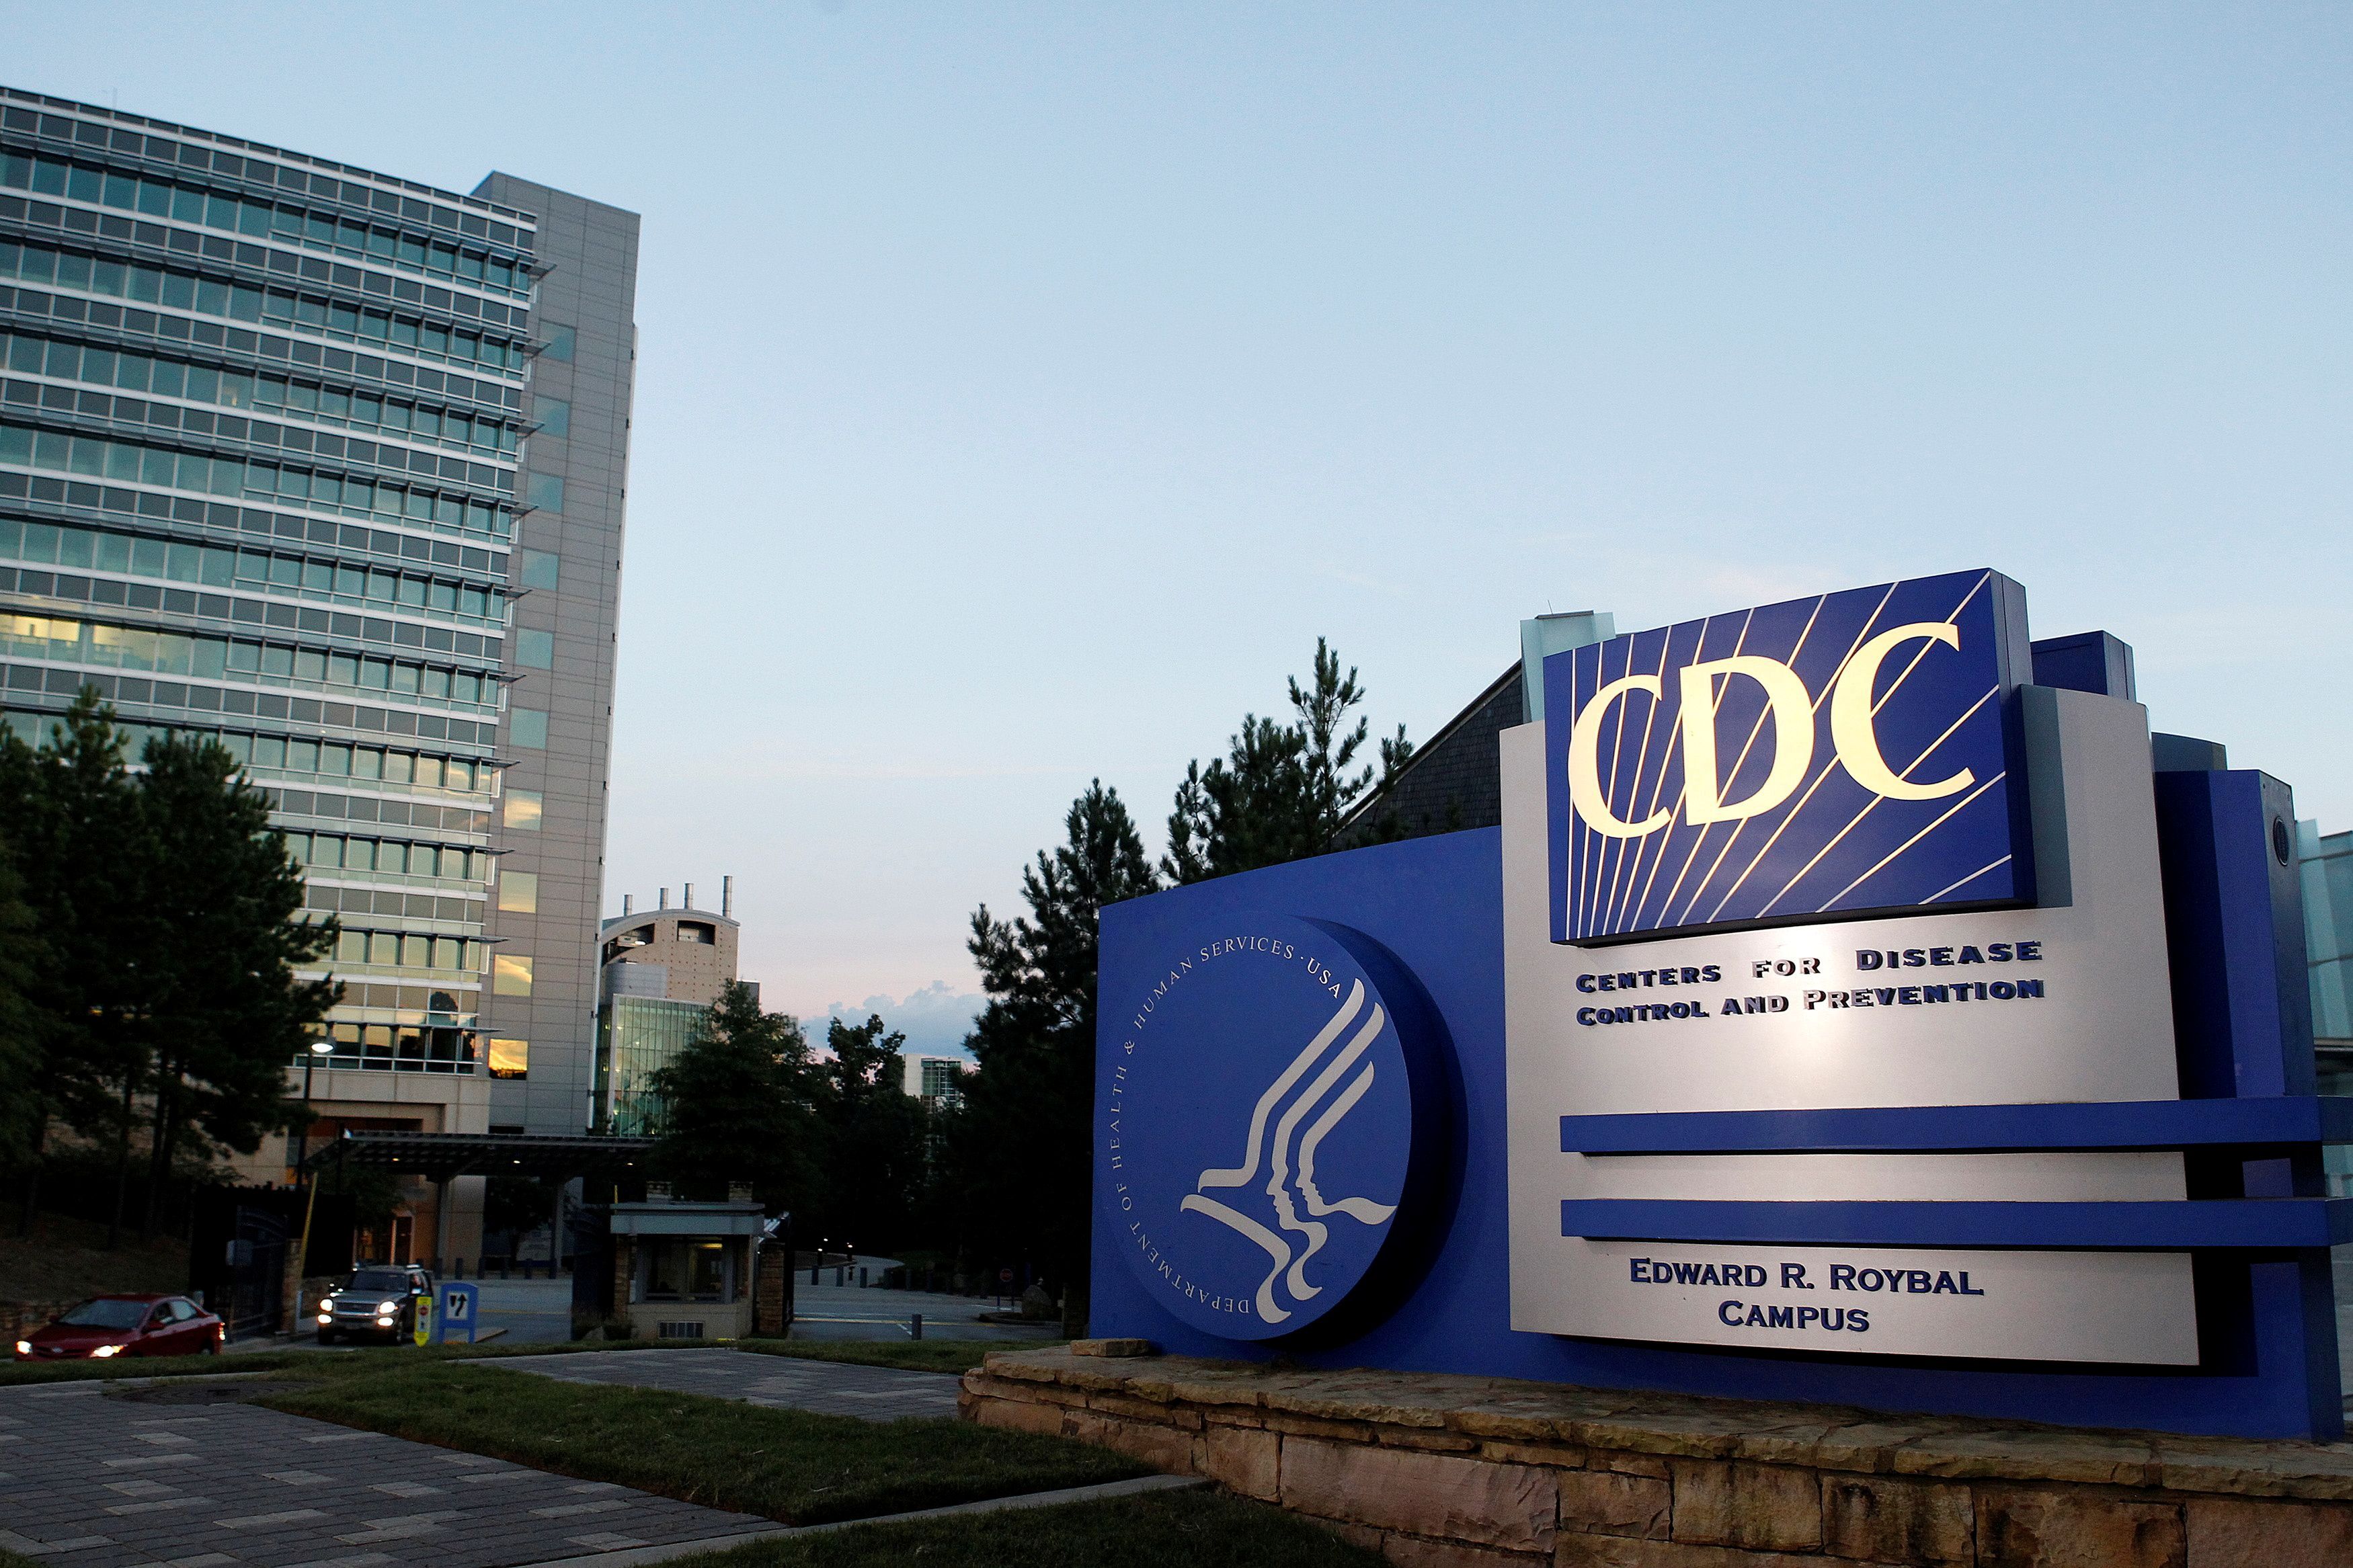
951,780,1160,1333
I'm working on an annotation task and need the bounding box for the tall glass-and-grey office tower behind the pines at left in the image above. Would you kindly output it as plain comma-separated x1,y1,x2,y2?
0,89,635,1255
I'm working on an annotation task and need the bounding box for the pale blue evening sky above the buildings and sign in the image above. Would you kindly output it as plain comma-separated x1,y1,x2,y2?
0,0,2353,1048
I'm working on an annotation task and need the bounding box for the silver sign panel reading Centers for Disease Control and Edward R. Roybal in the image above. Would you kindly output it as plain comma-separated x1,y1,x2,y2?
1501,689,2198,1366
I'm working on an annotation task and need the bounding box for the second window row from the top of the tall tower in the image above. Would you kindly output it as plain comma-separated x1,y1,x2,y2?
0,242,530,374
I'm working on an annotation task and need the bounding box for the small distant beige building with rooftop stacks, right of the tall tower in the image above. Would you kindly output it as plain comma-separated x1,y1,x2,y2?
596,882,739,1135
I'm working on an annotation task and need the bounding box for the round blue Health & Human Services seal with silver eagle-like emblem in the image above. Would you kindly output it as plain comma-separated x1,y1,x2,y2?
1096,915,1452,1340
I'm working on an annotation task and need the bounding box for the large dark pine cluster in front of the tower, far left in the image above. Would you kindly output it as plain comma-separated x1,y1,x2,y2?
0,686,337,1246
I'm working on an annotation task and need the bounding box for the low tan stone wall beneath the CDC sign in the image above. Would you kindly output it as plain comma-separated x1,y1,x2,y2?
963,1340,2353,1568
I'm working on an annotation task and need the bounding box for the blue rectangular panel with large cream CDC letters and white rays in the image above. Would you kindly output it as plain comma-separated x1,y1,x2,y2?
1544,571,2033,943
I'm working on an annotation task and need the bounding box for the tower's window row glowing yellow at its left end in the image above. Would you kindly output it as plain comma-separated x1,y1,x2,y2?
0,611,499,710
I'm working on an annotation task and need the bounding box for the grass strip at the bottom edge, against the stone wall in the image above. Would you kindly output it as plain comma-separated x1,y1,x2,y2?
676,1491,1386,1568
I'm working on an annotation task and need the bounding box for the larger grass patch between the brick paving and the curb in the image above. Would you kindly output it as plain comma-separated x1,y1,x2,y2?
264,1352,1148,1524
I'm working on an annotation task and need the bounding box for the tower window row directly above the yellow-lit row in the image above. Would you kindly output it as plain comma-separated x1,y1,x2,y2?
0,518,506,623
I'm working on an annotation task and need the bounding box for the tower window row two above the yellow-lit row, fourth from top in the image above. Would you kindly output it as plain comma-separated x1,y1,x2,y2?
0,423,513,534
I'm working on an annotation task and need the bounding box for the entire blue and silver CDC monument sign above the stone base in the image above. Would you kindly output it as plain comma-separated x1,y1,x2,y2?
1092,571,2353,1439
